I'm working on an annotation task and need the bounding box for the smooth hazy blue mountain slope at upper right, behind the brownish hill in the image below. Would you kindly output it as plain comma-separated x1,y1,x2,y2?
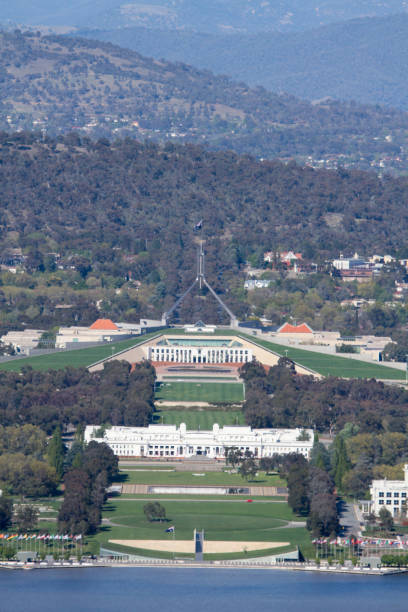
81,12,408,110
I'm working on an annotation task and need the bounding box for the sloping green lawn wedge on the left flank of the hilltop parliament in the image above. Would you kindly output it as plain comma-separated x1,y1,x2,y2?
0,332,161,372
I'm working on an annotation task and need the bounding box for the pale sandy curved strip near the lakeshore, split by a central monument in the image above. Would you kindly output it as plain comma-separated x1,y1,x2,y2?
109,536,289,553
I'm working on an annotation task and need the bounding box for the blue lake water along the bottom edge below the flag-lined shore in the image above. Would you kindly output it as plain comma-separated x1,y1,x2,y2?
0,568,408,612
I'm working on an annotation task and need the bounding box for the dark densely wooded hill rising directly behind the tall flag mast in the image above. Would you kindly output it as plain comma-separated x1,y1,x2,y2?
0,133,408,320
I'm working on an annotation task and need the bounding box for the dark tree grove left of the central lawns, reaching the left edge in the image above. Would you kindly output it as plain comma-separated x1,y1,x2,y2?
0,361,155,432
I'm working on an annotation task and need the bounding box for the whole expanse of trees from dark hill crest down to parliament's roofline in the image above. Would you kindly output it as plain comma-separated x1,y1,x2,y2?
0,134,408,334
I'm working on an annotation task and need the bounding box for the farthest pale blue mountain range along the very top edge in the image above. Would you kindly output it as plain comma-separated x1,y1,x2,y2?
0,0,407,33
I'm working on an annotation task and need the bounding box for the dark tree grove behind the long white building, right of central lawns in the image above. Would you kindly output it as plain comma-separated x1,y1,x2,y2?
241,364,408,436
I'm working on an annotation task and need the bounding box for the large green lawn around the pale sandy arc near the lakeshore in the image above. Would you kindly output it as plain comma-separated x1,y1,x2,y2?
90,498,310,557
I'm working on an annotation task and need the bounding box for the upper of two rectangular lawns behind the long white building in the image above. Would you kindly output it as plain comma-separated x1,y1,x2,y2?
156,382,244,404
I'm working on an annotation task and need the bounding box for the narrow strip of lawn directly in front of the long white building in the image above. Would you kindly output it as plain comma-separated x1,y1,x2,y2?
121,467,286,487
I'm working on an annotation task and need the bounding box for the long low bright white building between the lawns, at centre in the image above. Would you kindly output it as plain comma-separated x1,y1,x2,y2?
85,423,313,459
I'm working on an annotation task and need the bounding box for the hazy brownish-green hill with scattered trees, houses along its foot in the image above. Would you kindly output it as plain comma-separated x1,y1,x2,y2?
0,32,408,175
